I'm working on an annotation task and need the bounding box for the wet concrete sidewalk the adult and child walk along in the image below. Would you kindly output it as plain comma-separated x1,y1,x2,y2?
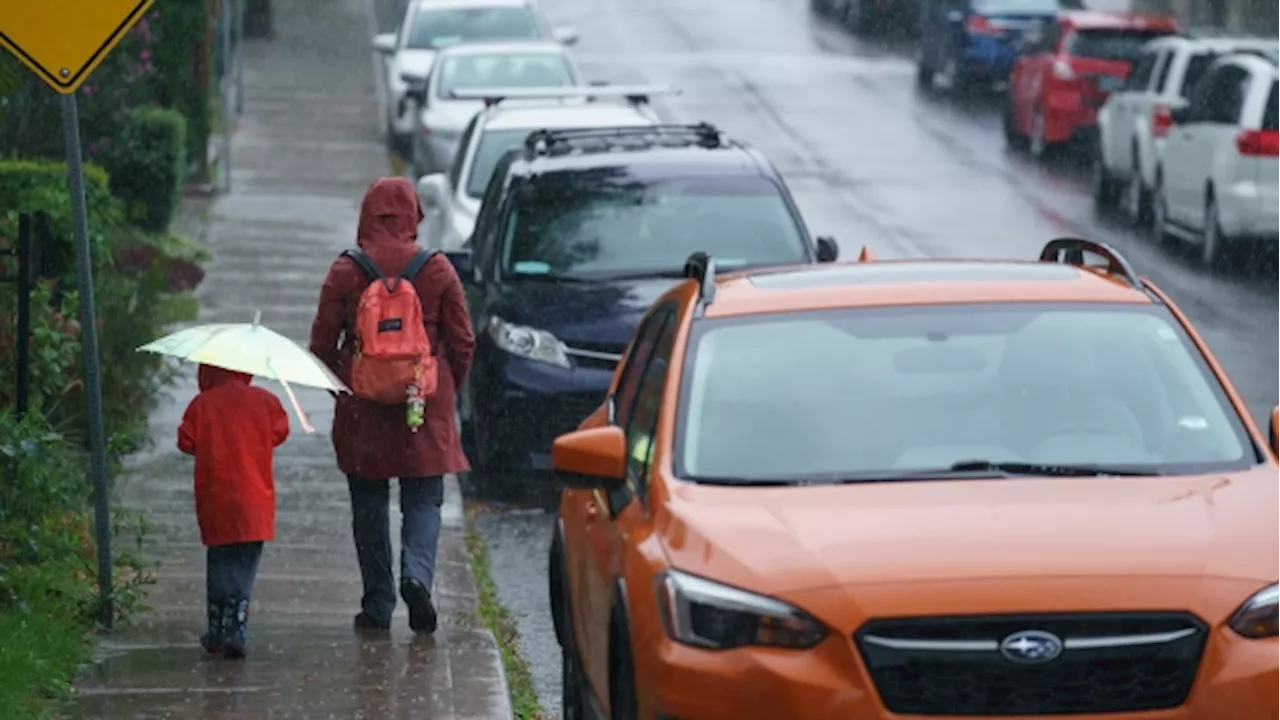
59,0,511,720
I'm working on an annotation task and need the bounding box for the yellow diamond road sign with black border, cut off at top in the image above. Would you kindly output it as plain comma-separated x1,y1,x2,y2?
0,0,155,95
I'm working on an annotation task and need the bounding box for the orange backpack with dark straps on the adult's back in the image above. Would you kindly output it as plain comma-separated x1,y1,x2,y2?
343,250,439,405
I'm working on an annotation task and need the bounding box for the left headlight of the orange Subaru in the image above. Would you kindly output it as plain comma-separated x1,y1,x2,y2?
657,570,827,650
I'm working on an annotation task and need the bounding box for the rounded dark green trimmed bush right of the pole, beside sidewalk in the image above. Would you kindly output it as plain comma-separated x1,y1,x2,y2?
105,108,187,232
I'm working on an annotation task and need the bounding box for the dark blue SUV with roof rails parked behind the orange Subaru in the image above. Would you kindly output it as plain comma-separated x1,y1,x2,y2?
448,124,837,487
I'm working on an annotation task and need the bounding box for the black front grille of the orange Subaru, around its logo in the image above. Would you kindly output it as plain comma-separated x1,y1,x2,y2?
855,612,1207,716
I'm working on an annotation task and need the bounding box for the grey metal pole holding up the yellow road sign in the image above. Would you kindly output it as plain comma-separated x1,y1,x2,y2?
63,94,115,630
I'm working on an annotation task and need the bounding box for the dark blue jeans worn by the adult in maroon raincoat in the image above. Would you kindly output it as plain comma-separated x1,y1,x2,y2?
347,475,444,623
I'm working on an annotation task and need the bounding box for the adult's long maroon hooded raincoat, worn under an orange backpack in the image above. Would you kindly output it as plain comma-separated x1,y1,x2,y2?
311,178,475,479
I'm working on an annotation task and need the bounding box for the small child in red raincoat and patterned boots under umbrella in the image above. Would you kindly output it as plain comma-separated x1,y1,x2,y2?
178,365,289,659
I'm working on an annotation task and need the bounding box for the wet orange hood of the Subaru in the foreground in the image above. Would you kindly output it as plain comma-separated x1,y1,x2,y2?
655,469,1280,594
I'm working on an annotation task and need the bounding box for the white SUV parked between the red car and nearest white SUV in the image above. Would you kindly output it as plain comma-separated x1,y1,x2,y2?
1093,36,1280,225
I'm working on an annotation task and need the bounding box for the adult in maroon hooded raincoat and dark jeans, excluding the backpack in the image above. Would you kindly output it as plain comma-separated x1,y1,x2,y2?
311,178,475,633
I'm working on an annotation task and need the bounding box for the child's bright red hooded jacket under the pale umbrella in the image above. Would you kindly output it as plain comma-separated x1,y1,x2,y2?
178,365,289,546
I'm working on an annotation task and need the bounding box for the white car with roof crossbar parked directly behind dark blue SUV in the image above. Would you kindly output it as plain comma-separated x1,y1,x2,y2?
417,86,677,251
